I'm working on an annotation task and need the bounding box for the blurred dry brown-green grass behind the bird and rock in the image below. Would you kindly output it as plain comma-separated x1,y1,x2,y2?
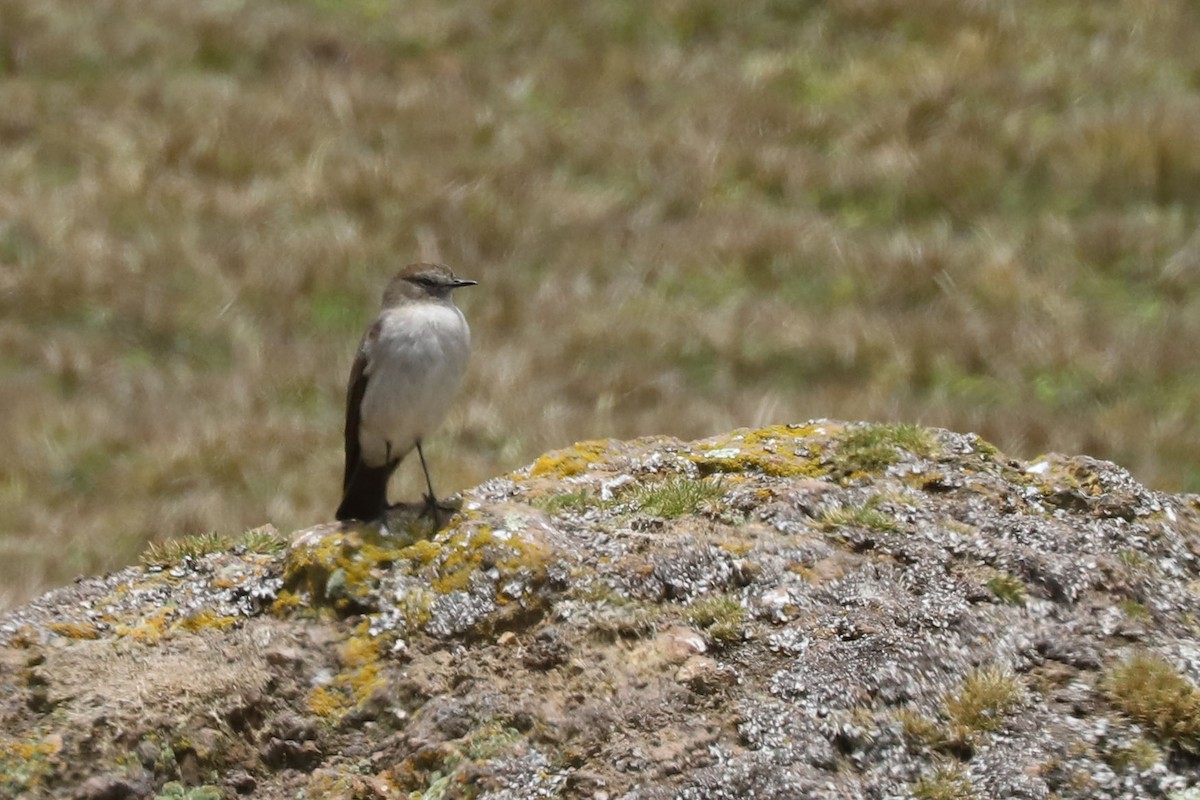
0,0,1200,607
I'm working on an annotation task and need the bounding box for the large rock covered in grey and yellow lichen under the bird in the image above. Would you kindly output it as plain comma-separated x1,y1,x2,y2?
0,421,1200,800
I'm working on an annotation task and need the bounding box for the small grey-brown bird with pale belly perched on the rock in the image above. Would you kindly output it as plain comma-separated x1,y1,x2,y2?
337,264,476,521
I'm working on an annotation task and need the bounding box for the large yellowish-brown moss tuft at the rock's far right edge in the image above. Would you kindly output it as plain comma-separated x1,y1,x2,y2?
1103,652,1200,753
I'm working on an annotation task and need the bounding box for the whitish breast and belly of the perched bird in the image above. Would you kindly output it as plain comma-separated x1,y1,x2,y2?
359,302,470,467
